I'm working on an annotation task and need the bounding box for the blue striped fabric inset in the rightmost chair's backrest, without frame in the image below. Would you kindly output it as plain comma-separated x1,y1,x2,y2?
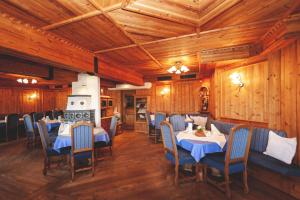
230,128,249,160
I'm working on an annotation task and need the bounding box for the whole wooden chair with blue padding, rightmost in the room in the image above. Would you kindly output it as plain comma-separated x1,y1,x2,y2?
200,125,252,198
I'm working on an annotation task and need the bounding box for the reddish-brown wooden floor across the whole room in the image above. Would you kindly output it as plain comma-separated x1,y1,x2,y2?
0,132,293,200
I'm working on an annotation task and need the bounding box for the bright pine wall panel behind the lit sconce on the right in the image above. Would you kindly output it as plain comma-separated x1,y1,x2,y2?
220,62,268,122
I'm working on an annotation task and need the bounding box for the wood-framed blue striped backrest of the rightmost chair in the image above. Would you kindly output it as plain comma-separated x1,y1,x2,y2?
225,125,252,161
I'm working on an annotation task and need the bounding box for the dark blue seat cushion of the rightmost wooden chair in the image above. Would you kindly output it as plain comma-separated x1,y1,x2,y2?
200,152,245,174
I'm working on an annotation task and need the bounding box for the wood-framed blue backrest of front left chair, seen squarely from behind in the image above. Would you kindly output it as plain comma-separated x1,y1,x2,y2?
71,122,94,152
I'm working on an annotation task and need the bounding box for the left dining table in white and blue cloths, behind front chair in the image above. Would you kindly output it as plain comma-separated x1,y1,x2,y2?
53,124,110,151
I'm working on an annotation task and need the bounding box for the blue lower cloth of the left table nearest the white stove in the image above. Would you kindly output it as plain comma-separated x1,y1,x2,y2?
53,129,110,151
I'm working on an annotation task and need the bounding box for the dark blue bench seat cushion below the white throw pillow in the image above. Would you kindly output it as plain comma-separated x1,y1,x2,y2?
248,151,300,176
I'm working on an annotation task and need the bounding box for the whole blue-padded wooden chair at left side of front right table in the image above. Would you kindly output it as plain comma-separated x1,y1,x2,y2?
160,121,199,185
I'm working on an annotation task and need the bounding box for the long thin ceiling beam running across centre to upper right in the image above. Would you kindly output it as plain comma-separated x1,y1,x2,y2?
94,18,276,54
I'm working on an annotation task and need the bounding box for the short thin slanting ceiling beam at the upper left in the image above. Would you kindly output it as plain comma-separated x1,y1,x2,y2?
42,3,122,30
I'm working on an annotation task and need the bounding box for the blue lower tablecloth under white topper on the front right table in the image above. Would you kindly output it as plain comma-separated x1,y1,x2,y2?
175,133,223,162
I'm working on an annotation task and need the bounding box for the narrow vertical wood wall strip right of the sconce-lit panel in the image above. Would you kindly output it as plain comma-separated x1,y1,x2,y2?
268,51,281,130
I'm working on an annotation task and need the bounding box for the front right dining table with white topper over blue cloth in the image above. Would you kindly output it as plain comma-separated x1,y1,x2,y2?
174,131,226,162
